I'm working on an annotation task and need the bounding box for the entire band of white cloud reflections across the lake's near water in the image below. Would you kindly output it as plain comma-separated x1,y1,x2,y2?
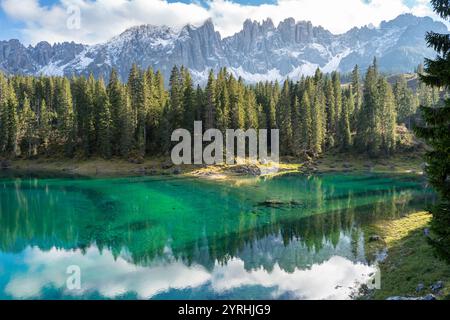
4,247,375,300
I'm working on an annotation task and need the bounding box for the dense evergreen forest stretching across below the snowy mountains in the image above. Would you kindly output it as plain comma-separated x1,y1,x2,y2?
0,60,440,159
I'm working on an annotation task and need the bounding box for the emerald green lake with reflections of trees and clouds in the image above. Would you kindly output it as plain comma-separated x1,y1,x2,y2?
0,174,433,299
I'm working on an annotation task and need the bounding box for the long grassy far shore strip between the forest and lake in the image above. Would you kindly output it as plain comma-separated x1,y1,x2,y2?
2,153,423,178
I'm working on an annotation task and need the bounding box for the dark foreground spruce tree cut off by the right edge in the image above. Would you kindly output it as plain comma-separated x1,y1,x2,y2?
416,0,450,251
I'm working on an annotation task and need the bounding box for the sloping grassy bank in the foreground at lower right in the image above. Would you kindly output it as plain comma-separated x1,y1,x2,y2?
366,212,450,299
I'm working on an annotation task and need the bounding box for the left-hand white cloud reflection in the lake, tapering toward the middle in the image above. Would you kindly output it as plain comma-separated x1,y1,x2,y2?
5,247,211,299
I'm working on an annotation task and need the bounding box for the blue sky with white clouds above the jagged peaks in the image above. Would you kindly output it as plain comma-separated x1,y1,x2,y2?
0,0,440,45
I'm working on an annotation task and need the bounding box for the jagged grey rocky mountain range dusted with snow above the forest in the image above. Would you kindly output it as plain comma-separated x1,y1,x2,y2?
0,14,448,83
